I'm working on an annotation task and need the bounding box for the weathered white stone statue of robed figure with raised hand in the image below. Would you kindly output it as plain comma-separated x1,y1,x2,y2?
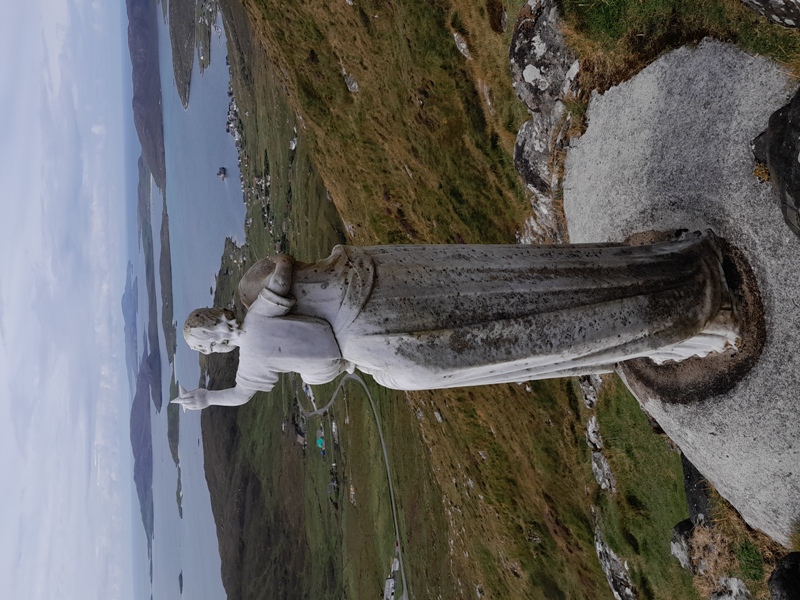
174,231,738,409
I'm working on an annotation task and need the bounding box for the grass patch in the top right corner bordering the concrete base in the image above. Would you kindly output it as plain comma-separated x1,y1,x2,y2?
560,0,800,93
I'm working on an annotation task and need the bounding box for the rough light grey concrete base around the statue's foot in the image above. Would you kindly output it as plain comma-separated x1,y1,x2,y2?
564,41,800,545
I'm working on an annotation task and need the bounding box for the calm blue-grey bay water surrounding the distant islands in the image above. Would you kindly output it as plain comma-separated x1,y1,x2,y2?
133,9,245,600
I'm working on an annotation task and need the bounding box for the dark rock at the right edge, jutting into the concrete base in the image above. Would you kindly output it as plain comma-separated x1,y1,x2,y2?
753,88,800,236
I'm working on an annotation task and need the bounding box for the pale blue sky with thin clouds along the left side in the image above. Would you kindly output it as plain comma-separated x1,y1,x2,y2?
0,0,134,600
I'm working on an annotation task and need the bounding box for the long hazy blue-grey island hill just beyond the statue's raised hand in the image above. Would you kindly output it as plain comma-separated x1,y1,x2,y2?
130,339,155,580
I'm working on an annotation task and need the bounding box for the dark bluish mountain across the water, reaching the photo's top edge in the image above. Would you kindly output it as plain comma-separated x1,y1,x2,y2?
125,0,167,190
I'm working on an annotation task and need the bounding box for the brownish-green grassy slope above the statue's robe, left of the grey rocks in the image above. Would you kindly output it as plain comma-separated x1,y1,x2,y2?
238,0,529,245
